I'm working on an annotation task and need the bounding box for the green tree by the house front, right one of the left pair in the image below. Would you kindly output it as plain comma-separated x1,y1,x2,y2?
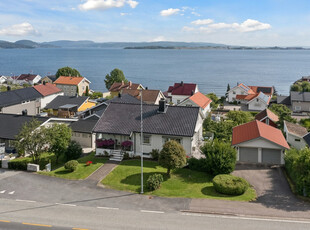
48,124,71,163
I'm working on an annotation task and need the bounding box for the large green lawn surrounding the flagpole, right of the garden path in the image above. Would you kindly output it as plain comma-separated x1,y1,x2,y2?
102,160,256,201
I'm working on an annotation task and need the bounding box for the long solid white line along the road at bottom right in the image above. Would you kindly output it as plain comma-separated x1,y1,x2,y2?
182,213,310,224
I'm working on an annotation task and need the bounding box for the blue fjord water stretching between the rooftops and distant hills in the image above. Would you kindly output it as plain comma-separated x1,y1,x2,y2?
0,48,310,95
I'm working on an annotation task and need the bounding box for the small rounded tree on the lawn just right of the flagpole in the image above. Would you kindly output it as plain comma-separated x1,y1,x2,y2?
159,140,186,175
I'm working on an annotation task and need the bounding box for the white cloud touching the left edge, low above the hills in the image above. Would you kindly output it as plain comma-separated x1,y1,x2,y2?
0,22,40,36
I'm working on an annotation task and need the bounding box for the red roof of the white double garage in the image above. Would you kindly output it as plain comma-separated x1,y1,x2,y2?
232,120,290,149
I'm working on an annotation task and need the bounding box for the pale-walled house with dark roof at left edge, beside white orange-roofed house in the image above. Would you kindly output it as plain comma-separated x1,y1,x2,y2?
0,87,42,115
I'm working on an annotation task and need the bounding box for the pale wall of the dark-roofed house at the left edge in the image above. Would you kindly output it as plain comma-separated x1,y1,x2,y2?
0,99,41,116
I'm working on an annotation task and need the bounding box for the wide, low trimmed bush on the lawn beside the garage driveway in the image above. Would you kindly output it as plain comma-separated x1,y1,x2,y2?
212,174,249,195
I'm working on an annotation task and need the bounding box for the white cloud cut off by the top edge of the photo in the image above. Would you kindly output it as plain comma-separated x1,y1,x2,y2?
79,0,139,11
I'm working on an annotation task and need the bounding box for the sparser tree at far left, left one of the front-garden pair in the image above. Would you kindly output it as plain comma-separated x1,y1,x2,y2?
15,119,49,163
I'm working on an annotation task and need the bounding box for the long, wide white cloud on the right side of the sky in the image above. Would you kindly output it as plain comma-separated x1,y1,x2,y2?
182,19,271,33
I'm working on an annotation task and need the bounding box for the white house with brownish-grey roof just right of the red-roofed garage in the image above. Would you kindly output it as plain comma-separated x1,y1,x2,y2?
284,121,309,149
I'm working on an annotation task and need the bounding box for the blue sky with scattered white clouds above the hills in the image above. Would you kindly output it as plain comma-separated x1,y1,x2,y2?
0,0,310,46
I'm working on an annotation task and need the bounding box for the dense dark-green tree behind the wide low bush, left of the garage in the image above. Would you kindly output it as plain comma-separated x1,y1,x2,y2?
201,140,237,176
